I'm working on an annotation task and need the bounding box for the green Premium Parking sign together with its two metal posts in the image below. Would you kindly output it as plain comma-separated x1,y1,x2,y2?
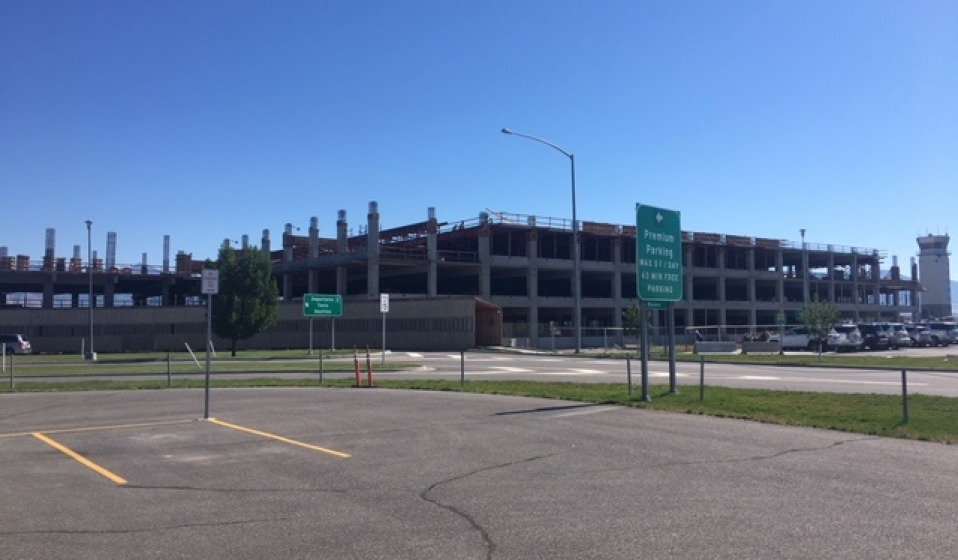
635,204,685,401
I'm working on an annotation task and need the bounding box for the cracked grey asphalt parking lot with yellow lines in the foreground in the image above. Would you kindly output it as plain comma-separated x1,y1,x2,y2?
0,388,958,559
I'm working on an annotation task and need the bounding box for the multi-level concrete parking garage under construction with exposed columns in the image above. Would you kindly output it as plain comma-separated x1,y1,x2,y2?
0,202,921,347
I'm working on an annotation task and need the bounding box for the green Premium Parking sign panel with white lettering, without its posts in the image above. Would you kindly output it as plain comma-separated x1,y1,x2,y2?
635,204,684,301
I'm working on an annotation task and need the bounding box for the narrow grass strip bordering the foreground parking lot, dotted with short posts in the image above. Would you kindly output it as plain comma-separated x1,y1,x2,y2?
0,378,958,444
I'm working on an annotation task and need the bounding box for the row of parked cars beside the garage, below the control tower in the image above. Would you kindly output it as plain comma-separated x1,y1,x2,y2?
768,321,958,352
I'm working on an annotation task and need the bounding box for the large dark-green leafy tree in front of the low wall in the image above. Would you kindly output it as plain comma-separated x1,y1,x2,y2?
212,245,279,356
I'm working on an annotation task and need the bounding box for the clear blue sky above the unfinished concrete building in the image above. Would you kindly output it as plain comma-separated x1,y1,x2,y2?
0,0,958,279
